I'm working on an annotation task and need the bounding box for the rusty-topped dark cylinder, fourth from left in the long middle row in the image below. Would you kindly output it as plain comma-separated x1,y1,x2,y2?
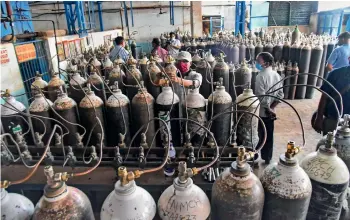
79,85,106,146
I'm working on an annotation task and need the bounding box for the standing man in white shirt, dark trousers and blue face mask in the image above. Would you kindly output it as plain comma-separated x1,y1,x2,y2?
255,52,283,164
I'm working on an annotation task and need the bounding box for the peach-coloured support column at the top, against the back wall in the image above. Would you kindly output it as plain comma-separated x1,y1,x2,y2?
191,1,203,38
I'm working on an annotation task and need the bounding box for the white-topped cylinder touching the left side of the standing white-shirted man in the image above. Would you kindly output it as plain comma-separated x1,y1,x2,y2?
236,89,260,149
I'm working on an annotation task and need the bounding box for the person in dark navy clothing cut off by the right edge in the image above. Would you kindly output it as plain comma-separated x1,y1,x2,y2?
313,56,350,135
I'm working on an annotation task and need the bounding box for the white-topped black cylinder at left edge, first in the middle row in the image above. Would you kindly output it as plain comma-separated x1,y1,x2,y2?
1,89,33,143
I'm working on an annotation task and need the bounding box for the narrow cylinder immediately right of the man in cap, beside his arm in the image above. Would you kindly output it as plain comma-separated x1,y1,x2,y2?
196,59,211,99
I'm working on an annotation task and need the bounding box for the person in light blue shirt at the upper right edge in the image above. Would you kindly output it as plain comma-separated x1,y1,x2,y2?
327,32,350,72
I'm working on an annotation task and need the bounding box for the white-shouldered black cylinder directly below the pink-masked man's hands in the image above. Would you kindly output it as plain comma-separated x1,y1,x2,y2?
156,86,181,146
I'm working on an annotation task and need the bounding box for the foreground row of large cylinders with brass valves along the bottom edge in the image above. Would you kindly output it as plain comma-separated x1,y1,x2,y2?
1,120,350,220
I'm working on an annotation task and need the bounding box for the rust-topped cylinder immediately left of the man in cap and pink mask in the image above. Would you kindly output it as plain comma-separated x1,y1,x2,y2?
143,59,161,98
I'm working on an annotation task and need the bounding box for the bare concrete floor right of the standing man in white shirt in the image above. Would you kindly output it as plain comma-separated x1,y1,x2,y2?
255,91,322,176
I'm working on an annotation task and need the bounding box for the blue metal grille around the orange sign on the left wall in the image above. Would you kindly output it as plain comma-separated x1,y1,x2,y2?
15,40,51,100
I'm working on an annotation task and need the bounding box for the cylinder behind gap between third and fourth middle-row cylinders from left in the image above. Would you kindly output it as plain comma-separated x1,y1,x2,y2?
67,72,86,103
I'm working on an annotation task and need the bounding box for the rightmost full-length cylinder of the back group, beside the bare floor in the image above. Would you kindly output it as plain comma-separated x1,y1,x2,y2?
305,45,323,99
